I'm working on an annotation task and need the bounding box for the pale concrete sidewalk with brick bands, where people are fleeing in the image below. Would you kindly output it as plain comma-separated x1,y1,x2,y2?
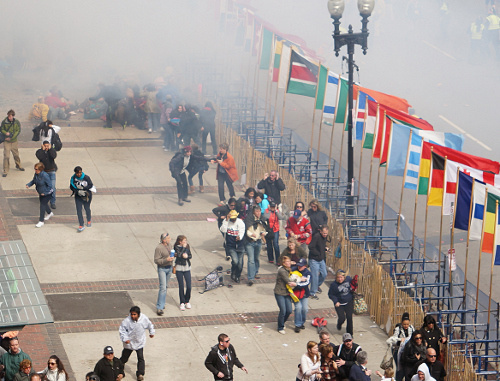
6,120,387,380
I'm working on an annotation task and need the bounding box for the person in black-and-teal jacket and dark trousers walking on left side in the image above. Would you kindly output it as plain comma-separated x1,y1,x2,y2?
69,166,96,233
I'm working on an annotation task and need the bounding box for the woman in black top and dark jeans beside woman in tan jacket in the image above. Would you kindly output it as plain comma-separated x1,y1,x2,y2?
174,235,192,311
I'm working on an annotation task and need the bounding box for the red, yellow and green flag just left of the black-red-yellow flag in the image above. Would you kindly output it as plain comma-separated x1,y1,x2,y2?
418,142,500,194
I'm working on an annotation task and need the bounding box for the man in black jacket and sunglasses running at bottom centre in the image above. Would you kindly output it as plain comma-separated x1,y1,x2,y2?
205,333,248,381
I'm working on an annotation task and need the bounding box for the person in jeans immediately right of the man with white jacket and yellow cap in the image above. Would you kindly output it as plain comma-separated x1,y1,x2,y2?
245,205,267,286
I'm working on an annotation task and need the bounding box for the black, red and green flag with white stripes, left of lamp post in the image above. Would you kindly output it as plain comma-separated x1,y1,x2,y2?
286,49,319,98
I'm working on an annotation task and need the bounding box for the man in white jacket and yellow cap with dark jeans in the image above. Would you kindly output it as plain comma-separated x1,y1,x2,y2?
220,210,245,283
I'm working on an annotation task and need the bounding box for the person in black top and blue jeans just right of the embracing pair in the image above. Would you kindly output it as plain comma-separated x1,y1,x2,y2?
309,226,330,298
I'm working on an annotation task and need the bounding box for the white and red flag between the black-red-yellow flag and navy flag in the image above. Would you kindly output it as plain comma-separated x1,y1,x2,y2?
443,160,500,215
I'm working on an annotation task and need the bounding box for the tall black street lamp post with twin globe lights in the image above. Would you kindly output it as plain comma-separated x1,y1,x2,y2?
328,0,375,215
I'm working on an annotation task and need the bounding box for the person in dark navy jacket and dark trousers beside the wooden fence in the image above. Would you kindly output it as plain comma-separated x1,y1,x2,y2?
328,270,354,335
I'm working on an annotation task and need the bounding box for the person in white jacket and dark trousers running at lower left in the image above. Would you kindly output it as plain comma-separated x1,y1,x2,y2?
119,306,155,381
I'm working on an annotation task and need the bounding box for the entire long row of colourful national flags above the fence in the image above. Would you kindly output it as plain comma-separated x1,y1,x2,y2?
223,1,500,265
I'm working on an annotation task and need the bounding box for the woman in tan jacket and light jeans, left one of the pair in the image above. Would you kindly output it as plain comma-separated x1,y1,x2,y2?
154,232,175,316
